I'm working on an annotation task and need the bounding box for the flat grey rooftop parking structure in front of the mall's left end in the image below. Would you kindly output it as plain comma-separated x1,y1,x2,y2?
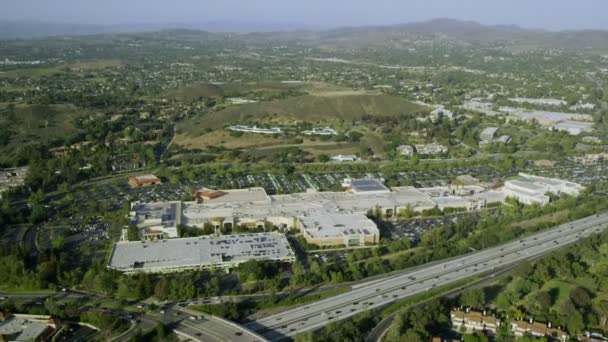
108,233,295,274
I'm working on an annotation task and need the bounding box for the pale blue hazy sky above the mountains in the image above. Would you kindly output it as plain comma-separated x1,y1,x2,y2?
0,0,608,29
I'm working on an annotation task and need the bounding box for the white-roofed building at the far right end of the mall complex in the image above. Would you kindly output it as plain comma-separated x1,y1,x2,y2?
502,173,583,205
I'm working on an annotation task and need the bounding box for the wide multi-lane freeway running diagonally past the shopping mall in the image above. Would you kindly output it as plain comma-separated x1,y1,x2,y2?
246,214,608,341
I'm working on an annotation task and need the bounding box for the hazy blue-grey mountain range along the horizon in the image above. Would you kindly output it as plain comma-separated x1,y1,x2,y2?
0,18,608,51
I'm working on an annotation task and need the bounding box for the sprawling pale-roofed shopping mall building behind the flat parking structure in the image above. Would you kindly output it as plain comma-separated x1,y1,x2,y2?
130,179,494,246
